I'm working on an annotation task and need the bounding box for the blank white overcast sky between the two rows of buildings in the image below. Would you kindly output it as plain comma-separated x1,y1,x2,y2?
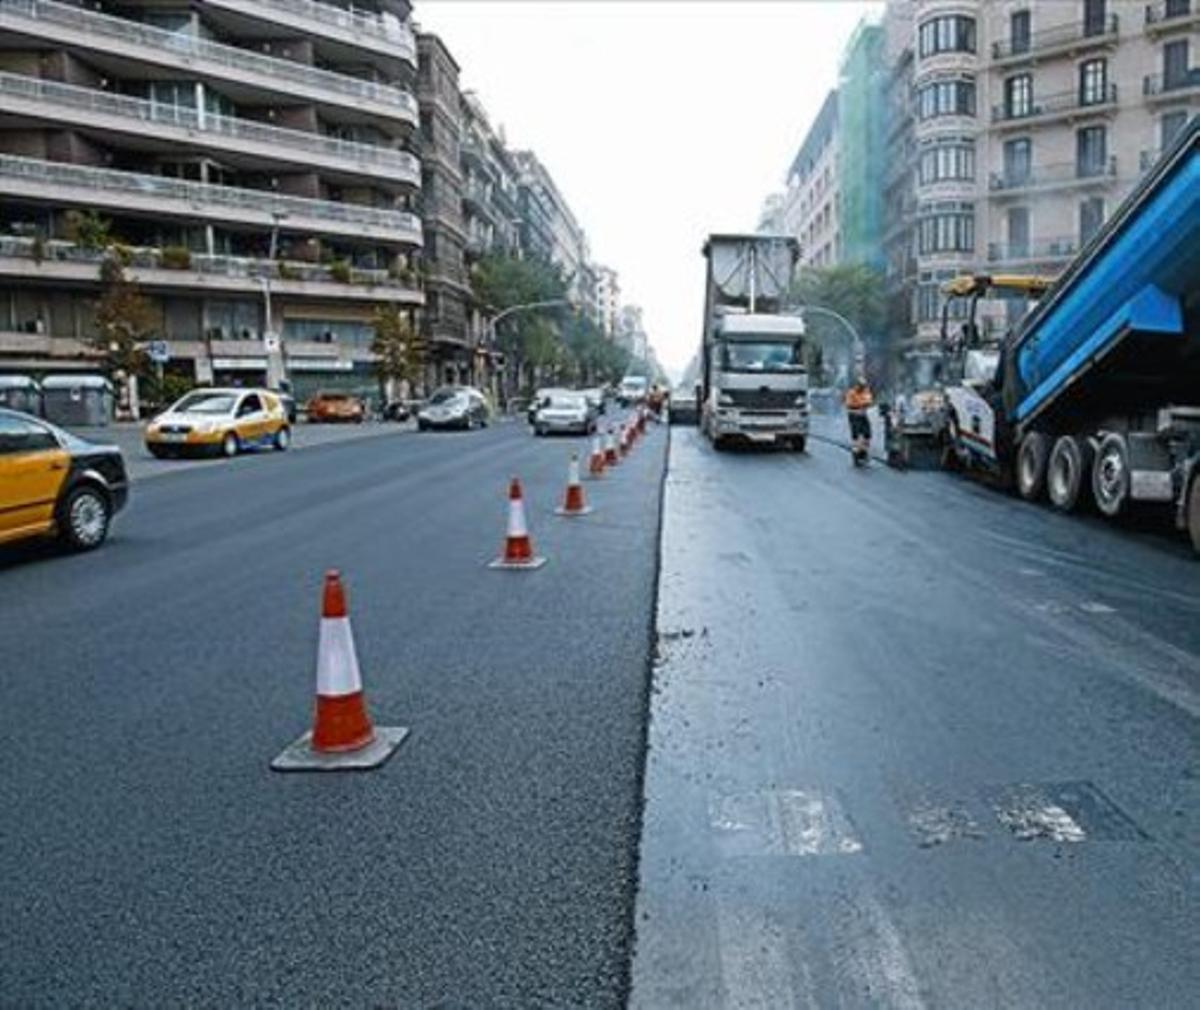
414,0,881,373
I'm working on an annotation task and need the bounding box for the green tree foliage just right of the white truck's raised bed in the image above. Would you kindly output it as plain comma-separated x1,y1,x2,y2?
792,263,887,383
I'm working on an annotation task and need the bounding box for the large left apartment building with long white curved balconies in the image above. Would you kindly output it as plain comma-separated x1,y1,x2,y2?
0,0,425,395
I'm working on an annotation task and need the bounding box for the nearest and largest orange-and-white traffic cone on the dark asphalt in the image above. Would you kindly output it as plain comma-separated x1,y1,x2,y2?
271,571,408,771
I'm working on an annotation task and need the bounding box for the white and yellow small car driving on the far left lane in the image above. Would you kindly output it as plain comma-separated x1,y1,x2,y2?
145,389,292,457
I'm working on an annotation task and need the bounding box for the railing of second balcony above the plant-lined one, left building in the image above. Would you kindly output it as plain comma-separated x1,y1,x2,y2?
0,73,421,185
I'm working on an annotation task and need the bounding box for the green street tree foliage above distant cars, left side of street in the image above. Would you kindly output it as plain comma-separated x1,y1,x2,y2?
472,254,629,383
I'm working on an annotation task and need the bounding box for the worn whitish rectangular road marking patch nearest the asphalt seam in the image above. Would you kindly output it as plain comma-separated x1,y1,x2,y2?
709,789,863,856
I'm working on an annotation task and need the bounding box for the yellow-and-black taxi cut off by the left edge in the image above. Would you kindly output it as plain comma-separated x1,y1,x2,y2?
0,408,128,551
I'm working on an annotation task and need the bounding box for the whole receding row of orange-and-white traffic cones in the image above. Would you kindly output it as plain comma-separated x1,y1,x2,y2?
271,410,646,771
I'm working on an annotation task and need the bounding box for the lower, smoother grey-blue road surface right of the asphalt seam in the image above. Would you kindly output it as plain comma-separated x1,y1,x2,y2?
631,429,1200,1010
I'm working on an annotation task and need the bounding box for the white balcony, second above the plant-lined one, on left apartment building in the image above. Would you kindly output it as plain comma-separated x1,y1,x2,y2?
0,73,421,186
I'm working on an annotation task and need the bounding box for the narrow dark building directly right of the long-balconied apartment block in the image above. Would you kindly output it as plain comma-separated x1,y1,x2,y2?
416,31,475,385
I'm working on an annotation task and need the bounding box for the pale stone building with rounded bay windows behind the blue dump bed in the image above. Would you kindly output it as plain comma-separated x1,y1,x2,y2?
886,0,1200,344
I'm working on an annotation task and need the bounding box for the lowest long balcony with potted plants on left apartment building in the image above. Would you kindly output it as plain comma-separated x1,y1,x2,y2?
0,236,425,305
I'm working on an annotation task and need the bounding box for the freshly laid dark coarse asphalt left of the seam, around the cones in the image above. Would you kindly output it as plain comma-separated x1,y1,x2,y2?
0,412,667,1008
